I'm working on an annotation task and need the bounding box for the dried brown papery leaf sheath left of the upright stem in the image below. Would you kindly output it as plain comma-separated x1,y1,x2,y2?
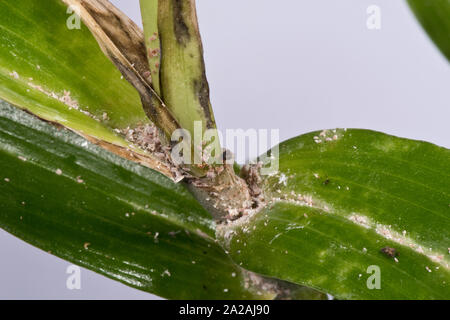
62,0,179,137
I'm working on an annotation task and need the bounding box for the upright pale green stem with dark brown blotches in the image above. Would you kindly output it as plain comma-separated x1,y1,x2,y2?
140,0,216,137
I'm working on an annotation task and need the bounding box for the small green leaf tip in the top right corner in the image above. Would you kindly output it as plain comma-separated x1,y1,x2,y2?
408,0,450,60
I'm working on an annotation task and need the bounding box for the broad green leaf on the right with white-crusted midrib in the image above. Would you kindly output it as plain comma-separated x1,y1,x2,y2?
221,130,450,299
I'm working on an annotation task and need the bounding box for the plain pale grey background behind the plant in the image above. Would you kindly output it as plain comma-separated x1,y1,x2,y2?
0,0,450,299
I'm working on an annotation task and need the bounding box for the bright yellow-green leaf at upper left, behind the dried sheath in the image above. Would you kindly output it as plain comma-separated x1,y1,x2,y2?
0,0,148,155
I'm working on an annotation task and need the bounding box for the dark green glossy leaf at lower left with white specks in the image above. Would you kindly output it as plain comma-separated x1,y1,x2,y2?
0,102,267,299
